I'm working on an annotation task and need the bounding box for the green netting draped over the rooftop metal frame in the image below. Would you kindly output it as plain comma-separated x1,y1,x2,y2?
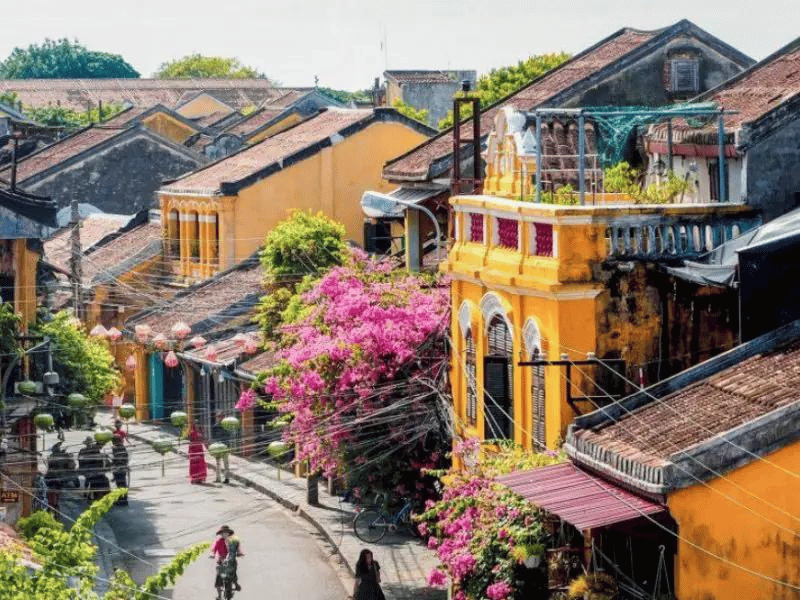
583,102,718,168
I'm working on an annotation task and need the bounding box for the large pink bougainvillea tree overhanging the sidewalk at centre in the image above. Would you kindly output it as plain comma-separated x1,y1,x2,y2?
264,253,449,497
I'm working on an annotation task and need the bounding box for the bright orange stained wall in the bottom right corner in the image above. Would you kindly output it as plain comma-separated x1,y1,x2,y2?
667,442,800,600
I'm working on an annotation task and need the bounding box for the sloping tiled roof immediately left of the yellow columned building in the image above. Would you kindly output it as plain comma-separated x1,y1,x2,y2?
82,223,162,283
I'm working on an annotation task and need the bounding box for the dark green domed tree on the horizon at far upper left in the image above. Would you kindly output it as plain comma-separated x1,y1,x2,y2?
0,38,139,79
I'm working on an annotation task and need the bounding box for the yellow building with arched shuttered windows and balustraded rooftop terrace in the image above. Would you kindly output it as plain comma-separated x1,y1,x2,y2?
441,105,758,448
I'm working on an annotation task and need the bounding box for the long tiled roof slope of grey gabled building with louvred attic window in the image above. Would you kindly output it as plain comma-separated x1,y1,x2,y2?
383,29,660,179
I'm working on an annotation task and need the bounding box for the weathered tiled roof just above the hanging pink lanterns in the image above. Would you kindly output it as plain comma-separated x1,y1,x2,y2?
126,259,264,336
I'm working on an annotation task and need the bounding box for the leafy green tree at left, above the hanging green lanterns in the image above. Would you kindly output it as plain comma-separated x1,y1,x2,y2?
32,311,119,404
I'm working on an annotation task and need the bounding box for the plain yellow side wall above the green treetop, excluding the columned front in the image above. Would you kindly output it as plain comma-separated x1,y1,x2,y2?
231,122,427,262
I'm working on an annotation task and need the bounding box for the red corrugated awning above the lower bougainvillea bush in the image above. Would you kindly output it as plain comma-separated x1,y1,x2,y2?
497,463,666,531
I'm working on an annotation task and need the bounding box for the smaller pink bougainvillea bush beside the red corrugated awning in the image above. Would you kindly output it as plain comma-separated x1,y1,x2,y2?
418,439,561,600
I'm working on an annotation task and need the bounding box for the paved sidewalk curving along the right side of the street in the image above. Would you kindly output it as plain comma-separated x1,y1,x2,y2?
108,415,447,600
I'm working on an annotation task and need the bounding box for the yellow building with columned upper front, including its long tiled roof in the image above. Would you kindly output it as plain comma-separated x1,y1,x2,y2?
158,109,432,280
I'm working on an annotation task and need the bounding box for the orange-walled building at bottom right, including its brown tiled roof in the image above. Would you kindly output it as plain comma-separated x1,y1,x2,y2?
548,321,800,600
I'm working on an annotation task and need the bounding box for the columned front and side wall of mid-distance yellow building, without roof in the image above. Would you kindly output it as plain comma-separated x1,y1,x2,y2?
159,115,427,280
